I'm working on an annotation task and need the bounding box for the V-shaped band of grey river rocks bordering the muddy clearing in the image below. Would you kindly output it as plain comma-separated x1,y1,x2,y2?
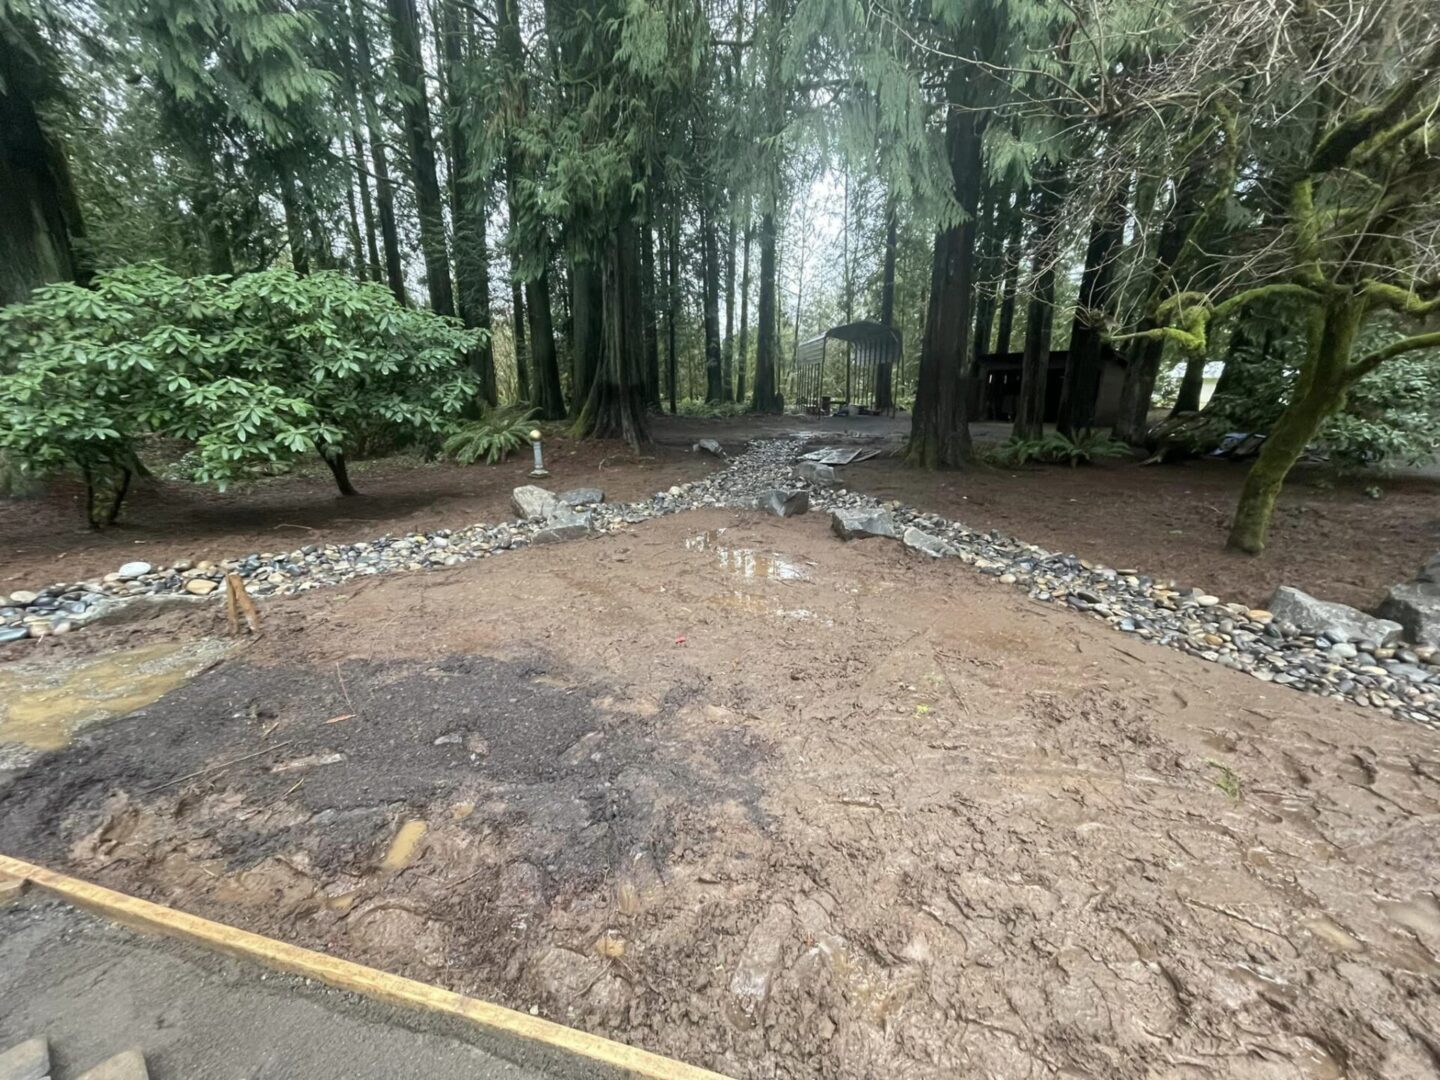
0,438,1440,730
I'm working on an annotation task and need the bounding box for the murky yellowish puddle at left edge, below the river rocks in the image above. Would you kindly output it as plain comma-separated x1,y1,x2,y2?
0,641,228,750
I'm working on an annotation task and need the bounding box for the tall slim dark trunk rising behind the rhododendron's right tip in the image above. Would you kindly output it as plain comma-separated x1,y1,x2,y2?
441,0,498,406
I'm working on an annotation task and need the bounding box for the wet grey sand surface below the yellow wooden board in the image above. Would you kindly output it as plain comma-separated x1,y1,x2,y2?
0,894,601,1080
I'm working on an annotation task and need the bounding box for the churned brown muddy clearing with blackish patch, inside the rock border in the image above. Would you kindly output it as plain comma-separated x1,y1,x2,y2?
0,511,1440,1080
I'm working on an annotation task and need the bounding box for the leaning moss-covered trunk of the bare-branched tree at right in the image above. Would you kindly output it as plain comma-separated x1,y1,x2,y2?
1230,295,1365,554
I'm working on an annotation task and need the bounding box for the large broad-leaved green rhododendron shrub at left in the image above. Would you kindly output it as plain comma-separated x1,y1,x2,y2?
0,264,480,526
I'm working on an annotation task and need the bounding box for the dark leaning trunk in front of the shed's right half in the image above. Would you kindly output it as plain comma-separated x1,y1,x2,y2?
1056,179,1130,438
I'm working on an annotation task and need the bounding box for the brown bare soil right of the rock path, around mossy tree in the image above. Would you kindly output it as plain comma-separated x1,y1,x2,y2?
844,458,1440,608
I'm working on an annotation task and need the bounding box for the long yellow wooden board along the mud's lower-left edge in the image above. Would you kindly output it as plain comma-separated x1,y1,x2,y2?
0,855,726,1080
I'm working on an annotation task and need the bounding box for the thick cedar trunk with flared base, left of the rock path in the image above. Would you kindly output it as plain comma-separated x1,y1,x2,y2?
576,213,649,449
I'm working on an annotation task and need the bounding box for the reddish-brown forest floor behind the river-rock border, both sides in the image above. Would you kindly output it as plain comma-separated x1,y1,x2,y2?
0,415,1440,622
